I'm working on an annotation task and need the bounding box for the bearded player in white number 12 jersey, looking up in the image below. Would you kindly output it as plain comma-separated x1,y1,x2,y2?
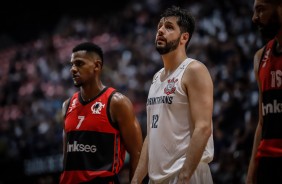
131,6,214,184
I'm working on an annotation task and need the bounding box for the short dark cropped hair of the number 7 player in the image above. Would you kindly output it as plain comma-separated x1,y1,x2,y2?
72,42,104,65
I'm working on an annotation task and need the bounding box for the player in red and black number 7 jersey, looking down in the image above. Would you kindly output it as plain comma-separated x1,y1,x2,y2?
60,42,142,184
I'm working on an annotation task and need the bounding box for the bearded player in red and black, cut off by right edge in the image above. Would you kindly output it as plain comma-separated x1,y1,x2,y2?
246,0,282,184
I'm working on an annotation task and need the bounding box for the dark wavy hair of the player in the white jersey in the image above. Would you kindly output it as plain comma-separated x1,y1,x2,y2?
161,5,195,47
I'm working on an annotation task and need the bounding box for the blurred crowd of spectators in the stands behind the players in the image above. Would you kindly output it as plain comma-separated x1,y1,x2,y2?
0,0,263,184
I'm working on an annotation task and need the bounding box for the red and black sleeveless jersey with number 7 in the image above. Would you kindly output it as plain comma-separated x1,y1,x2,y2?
60,88,125,184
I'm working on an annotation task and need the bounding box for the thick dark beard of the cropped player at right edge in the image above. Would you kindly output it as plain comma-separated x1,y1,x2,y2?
257,11,281,39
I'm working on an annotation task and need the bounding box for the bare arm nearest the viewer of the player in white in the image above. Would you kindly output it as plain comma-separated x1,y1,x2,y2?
179,61,213,182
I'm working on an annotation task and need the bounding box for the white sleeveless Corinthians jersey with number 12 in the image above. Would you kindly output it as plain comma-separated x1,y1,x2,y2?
147,58,214,183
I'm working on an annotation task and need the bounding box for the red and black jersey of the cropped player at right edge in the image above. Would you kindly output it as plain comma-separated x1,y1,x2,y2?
257,40,282,157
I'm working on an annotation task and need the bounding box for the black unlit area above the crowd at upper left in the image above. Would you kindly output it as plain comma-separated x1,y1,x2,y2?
0,0,133,43
